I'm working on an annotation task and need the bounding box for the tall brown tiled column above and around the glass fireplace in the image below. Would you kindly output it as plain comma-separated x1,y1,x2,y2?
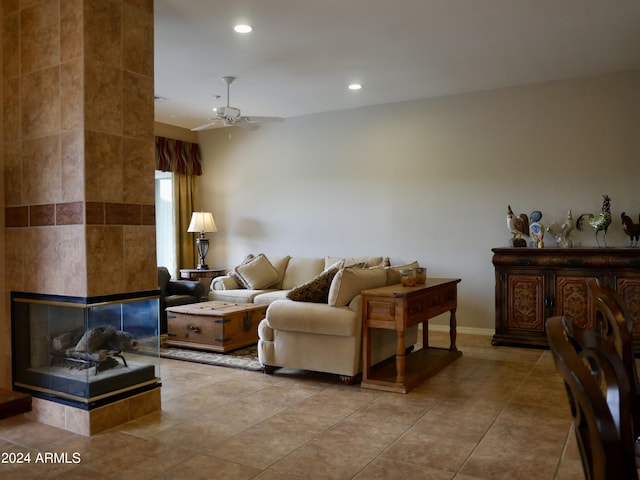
0,0,159,433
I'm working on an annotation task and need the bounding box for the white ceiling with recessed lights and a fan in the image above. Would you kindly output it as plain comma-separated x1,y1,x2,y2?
155,0,640,128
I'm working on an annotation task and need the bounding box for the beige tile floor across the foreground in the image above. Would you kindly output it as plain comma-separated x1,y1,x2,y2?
0,332,583,480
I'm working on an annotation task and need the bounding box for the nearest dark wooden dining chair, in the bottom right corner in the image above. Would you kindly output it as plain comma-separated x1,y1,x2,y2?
547,317,638,480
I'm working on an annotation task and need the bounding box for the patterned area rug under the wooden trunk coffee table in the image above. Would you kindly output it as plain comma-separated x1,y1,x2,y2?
137,342,262,372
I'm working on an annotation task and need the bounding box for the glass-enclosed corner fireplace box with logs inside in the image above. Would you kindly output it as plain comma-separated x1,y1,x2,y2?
11,290,160,410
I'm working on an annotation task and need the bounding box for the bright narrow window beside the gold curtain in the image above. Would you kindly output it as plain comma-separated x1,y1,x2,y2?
156,170,178,278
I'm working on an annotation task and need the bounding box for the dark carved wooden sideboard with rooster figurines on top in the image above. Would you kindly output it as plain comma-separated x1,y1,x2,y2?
492,248,640,348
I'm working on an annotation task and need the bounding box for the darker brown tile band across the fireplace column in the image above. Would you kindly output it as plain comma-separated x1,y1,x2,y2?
4,202,156,228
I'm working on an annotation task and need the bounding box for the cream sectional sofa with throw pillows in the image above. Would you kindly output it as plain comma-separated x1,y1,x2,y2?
209,254,417,383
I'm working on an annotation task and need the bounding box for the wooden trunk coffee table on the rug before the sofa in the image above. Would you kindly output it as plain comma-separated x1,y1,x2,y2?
166,301,267,352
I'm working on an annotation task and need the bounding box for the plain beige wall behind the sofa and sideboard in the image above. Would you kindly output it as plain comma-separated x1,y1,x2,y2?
199,72,640,329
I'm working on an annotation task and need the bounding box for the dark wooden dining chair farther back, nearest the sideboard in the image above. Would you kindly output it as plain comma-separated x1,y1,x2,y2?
587,278,640,437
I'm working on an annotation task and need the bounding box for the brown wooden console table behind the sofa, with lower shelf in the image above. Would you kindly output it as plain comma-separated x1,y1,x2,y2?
361,278,462,393
